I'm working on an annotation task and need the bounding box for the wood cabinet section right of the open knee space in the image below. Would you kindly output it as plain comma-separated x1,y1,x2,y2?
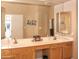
50,42,72,59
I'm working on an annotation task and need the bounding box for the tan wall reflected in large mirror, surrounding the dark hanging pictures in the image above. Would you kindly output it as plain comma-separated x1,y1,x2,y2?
2,2,53,38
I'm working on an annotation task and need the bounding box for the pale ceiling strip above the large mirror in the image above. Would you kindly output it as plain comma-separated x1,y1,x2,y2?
1,0,69,5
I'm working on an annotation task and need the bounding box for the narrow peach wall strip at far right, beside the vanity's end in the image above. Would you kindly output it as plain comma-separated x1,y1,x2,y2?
72,0,78,59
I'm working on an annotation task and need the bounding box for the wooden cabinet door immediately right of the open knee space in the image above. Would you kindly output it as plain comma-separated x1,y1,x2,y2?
50,47,62,59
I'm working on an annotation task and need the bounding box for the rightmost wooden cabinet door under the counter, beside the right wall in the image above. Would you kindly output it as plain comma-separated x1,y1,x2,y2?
63,43,72,59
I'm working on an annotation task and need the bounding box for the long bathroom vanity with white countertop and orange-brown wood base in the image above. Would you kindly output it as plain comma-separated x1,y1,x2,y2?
1,39,73,59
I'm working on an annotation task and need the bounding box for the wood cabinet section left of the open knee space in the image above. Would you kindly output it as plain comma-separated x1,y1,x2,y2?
2,48,35,59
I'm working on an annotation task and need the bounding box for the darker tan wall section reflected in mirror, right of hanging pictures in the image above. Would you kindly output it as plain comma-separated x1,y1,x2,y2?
38,6,49,37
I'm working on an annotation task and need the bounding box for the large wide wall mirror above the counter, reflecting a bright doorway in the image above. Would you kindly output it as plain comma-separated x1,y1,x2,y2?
1,2,54,39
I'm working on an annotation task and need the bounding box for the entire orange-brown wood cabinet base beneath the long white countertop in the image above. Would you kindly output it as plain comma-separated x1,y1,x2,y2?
1,42,72,59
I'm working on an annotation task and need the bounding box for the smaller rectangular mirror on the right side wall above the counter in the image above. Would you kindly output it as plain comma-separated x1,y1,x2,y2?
56,12,71,35
